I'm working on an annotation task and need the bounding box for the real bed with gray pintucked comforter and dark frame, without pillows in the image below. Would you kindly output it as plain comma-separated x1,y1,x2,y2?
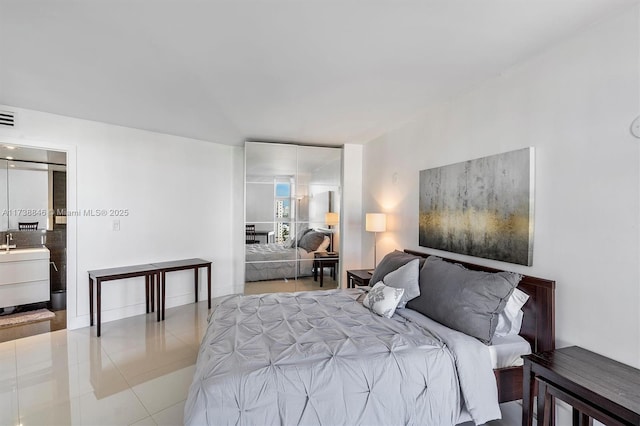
185,251,555,425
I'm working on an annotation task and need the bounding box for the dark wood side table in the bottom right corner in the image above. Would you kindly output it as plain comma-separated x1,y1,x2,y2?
522,346,640,426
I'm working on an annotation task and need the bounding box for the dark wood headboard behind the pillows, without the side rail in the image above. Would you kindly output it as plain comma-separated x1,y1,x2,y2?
405,250,556,352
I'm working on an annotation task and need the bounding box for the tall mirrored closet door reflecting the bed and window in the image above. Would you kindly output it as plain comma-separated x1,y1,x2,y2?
245,142,342,293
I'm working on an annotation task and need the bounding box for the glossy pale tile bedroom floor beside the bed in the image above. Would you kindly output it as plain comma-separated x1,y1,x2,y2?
0,292,520,426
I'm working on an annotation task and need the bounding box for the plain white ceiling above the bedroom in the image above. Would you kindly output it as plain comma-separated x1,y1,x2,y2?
0,0,638,145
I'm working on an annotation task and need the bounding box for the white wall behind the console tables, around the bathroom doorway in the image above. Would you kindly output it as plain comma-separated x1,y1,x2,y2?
0,106,243,328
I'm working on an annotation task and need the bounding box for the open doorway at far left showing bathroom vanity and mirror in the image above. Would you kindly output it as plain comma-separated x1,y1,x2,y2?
0,142,67,342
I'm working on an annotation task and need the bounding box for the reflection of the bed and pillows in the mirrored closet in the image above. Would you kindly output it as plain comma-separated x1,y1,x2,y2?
245,230,330,282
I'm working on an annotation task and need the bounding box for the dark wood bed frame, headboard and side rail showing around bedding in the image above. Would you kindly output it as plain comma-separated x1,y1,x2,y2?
405,250,556,402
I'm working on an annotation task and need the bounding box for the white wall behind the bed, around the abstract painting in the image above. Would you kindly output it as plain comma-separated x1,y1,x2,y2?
363,7,640,367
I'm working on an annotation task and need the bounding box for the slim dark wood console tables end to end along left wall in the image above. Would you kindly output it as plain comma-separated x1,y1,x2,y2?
88,259,211,337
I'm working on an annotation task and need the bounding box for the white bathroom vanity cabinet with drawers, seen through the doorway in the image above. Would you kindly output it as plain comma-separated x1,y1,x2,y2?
0,247,51,308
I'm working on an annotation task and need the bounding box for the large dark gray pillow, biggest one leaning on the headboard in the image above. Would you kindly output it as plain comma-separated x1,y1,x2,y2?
407,256,522,344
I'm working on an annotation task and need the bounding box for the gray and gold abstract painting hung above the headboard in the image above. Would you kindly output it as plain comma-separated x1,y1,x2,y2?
419,147,534,266
